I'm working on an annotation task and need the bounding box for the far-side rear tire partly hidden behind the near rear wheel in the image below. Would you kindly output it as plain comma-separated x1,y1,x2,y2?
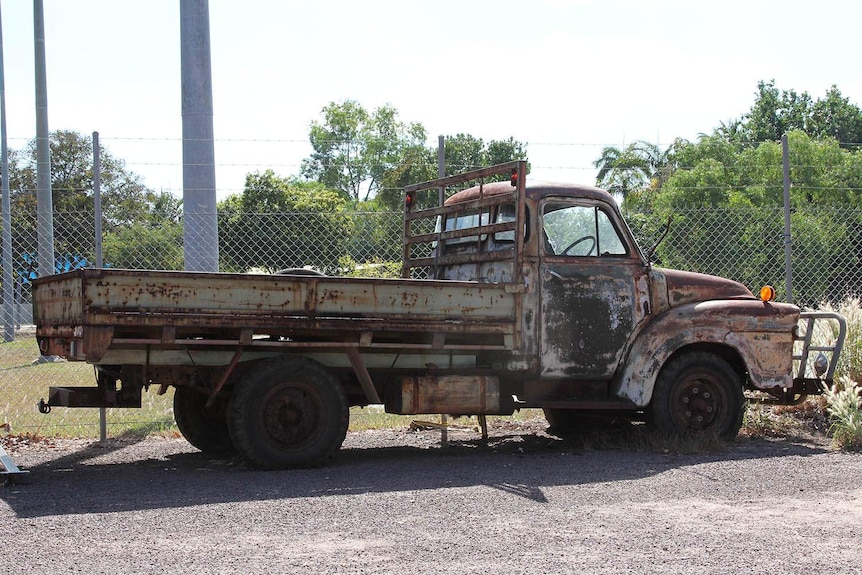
174,387,235,454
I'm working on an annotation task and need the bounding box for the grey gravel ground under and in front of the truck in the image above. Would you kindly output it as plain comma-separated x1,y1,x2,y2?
0,421,862,575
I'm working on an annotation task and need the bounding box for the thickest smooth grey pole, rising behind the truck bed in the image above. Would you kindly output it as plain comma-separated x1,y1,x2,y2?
180,0,218,272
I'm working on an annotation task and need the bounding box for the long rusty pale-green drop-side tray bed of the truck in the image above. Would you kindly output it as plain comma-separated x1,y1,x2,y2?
33,269,521,363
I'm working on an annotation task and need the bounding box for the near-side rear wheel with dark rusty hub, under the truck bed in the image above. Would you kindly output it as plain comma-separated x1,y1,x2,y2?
228,356,350,469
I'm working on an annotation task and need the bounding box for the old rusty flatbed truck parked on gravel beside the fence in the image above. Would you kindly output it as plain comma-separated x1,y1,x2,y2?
33,161,844,468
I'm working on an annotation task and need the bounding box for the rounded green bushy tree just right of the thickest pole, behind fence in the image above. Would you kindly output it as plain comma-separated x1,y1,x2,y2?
219,170,353,273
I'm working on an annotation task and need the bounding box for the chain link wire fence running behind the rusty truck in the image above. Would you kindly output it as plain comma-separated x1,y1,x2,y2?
0,202,862,437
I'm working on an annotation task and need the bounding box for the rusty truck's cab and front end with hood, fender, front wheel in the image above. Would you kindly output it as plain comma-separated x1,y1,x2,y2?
405,164,844,437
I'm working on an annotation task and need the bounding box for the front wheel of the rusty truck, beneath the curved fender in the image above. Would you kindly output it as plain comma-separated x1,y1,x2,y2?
647,352,745,440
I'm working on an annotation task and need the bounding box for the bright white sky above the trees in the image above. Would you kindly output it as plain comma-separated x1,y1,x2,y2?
0,0,862,199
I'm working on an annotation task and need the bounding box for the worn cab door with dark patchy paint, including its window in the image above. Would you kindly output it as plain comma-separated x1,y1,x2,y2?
540,199,649,381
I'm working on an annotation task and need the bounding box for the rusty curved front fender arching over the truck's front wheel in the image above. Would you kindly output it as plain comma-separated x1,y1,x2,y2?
614,300,798,407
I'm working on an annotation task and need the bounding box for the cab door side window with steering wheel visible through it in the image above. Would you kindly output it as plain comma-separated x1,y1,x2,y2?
542,202,628,257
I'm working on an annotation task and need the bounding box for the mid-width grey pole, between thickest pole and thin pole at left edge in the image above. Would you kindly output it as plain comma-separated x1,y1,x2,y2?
33,0,54,276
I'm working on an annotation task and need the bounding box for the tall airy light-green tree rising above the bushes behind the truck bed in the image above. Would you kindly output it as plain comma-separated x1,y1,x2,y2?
302,100,426,201
